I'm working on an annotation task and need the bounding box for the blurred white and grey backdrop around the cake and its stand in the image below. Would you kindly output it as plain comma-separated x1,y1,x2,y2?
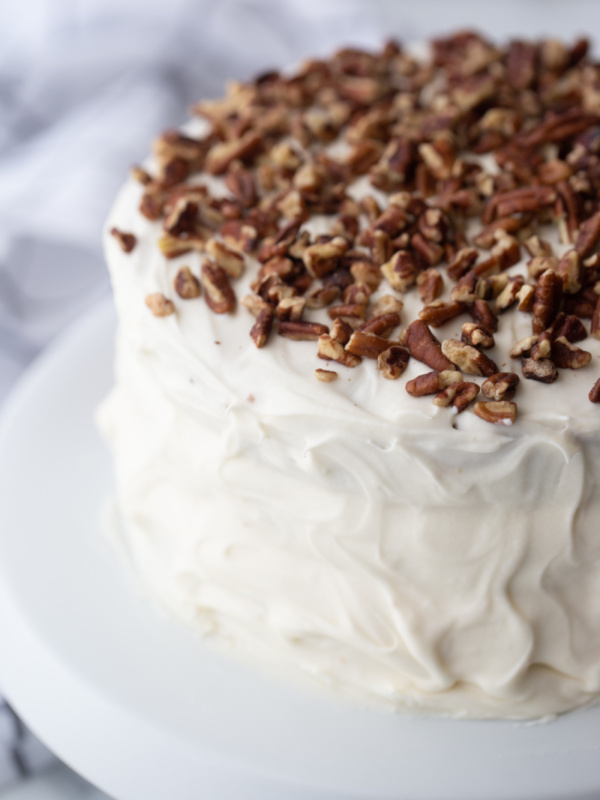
0,0,600,800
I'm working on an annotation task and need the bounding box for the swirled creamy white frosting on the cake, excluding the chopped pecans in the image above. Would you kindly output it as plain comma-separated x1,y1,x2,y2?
101,136,600,718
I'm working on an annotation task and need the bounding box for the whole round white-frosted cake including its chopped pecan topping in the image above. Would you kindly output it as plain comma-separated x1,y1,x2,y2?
100,33,600,718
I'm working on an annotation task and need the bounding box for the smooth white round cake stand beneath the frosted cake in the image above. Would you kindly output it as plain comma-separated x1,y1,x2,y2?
0,303,600,800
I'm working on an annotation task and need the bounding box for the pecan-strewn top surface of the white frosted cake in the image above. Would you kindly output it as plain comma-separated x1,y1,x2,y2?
107,33,600,446
